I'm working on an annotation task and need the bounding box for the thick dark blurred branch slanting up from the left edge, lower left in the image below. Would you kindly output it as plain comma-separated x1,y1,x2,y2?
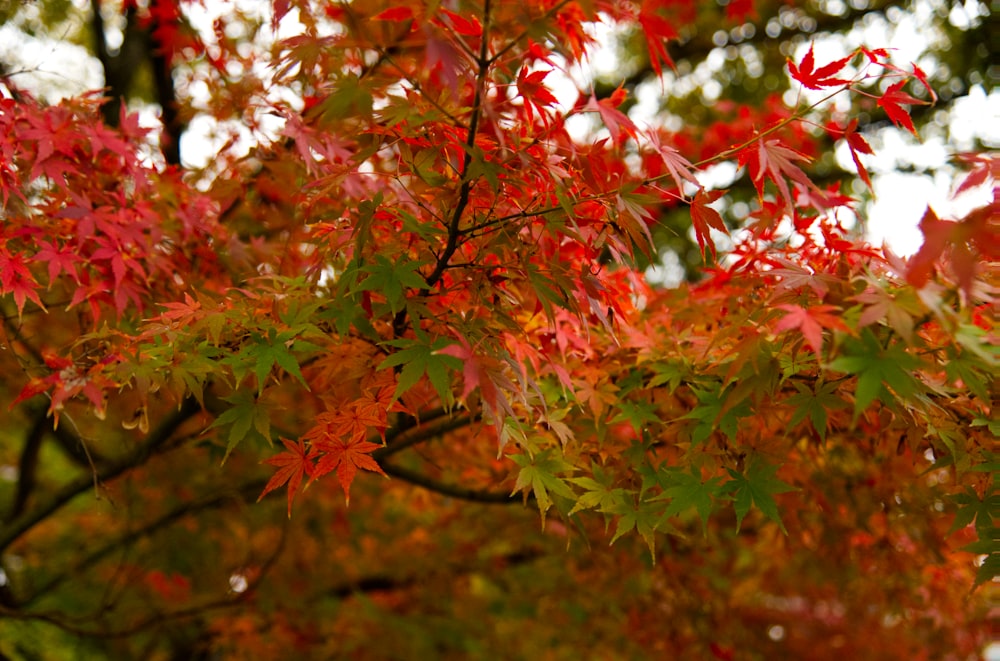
0,399,199,551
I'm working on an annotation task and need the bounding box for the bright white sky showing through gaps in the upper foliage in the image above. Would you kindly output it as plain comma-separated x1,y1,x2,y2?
0,0,1000,268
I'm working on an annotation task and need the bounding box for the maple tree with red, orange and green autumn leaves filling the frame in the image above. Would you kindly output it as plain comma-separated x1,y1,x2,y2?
0,0,988,659
